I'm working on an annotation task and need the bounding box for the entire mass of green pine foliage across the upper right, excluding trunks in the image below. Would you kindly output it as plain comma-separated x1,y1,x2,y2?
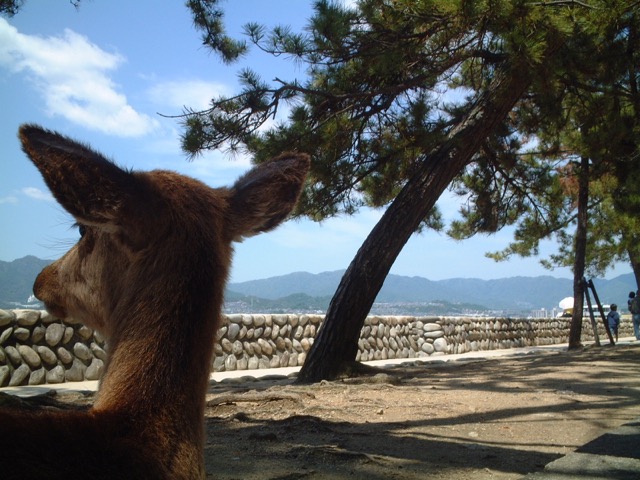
183,0,640,273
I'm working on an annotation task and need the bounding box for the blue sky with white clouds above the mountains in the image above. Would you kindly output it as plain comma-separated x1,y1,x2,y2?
0,0,631,282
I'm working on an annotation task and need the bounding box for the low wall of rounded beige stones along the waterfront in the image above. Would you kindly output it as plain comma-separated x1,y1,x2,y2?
0,310,633,387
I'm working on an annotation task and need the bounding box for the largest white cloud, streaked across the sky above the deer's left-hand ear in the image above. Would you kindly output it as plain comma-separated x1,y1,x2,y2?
0,18,158,137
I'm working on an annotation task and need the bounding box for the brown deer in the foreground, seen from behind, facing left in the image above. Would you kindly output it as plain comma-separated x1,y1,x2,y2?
0,124,310,479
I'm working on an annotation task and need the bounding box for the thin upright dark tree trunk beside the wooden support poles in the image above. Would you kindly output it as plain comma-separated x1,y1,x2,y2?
569,157,589,350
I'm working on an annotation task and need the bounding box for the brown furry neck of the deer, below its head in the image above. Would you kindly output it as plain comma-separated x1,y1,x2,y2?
94,278,222,436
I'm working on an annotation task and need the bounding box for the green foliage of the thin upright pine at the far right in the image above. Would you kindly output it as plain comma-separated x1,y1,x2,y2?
480,2,640,276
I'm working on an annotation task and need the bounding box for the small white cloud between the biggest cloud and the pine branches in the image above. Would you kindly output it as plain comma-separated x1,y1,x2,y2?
149,80,229,110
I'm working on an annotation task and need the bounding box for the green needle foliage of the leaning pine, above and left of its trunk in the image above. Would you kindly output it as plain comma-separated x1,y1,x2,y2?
183,0,580,223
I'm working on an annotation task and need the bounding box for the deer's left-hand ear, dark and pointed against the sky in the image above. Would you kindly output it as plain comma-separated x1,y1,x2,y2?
19,125,136,225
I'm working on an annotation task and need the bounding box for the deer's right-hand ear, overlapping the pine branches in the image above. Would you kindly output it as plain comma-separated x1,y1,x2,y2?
229,153,309,239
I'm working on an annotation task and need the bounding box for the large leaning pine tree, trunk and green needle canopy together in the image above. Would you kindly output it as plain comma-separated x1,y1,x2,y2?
183,0,632,382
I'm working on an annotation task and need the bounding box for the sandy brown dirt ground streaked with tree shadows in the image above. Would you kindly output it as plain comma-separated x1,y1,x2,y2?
5,342,640,480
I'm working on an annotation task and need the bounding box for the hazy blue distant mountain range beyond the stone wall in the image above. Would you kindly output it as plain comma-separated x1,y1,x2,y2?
0,256,636,315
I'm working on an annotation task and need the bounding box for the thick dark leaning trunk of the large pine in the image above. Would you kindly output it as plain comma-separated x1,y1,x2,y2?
298,63,530,383
